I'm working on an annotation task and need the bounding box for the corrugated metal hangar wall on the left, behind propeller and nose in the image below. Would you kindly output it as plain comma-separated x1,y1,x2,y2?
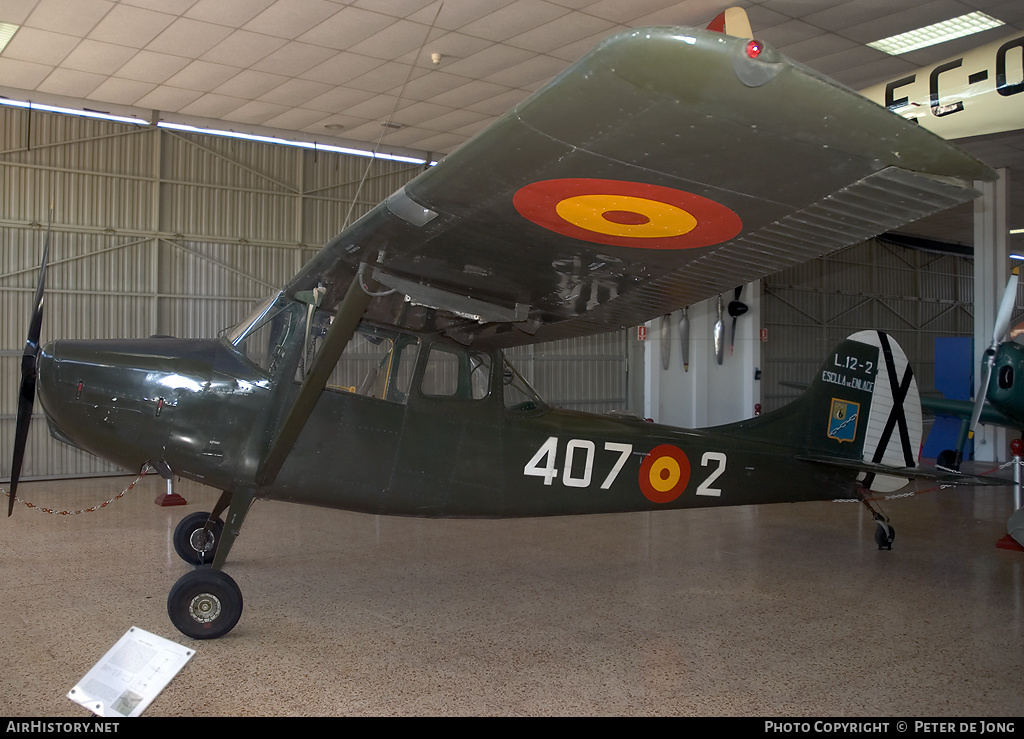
0,108,628,478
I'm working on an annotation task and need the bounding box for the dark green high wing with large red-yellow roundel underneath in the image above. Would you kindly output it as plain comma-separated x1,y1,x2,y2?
286,23,995,346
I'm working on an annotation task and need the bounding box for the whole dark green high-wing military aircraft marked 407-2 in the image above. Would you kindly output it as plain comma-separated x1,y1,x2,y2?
8,21,995,639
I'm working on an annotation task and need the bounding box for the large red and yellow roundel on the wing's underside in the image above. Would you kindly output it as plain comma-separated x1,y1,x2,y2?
512,177,743,249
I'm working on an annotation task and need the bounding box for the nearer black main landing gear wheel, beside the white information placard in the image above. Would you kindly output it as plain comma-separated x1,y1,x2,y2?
167,568,242,639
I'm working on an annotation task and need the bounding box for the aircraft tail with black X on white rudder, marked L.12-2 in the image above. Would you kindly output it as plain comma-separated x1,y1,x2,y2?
746,331,923,492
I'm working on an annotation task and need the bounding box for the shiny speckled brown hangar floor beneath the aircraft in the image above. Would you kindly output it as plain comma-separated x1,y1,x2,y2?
0,468,1024,718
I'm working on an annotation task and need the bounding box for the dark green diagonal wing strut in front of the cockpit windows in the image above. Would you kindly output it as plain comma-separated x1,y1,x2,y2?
256,270,373,485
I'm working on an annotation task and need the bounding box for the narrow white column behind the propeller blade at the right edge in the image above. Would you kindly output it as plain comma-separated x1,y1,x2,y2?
974,169,1010,462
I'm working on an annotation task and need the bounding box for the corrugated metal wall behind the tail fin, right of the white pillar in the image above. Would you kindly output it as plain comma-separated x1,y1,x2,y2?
761,240,974,411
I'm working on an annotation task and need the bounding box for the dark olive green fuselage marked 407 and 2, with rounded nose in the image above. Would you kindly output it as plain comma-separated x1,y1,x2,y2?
40,337,855,517
